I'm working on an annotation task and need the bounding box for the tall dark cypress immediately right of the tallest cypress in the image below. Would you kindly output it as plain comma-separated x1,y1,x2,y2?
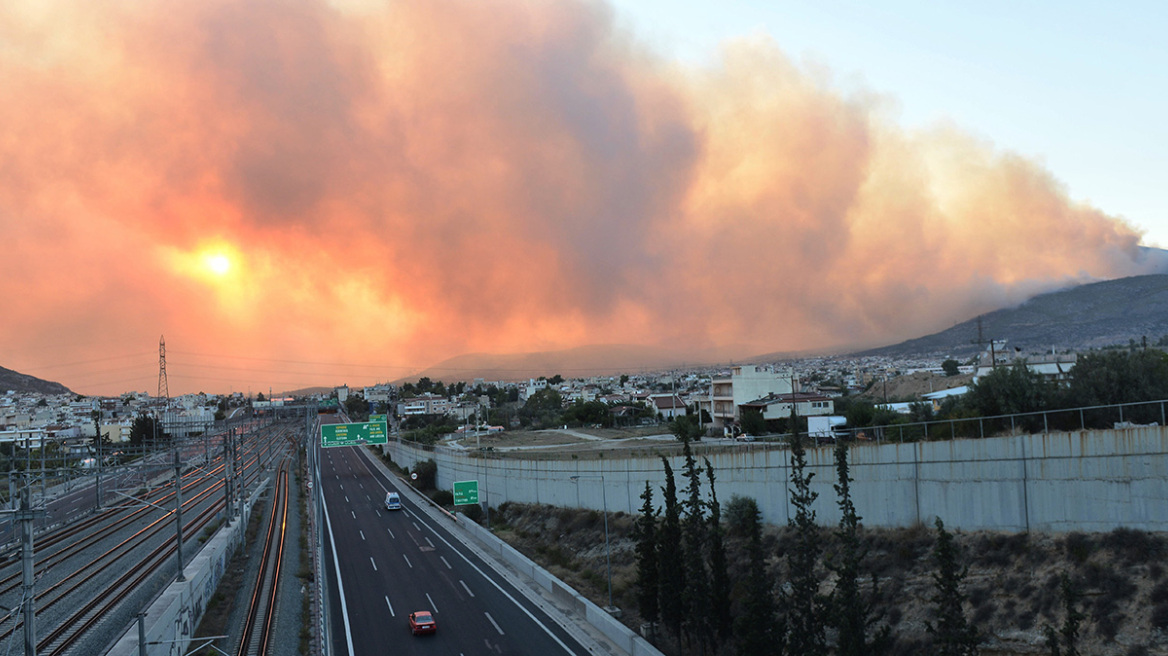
828,444,891,656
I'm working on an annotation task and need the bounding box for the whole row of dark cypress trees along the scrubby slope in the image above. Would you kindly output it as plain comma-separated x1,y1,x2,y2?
634,433,1082,656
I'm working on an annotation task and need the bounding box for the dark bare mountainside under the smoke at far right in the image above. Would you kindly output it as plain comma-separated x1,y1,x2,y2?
855,274,1168,360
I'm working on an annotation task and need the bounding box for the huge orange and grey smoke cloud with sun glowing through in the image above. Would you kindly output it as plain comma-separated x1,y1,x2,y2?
0,0,1149,395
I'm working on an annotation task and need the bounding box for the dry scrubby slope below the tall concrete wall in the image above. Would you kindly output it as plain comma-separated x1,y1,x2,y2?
492,500,1168,656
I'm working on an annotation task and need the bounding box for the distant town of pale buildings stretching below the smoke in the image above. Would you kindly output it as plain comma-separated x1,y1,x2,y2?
0,342,1077,451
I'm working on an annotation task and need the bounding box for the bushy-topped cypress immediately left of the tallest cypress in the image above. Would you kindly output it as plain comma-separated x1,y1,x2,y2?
735,492,786,656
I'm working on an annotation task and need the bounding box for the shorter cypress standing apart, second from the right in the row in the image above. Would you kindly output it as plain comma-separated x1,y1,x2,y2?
925,517,980,656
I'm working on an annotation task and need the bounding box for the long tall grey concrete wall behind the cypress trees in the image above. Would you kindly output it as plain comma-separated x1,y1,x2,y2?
384,426,1168,532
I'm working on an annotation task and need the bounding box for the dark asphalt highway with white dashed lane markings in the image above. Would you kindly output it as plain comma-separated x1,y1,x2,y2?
319,447,589,656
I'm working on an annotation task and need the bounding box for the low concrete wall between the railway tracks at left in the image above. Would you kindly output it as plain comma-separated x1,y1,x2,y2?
106,479,269,656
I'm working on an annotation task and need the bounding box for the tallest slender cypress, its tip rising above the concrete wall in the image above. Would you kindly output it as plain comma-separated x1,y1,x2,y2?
786,420,827,656
